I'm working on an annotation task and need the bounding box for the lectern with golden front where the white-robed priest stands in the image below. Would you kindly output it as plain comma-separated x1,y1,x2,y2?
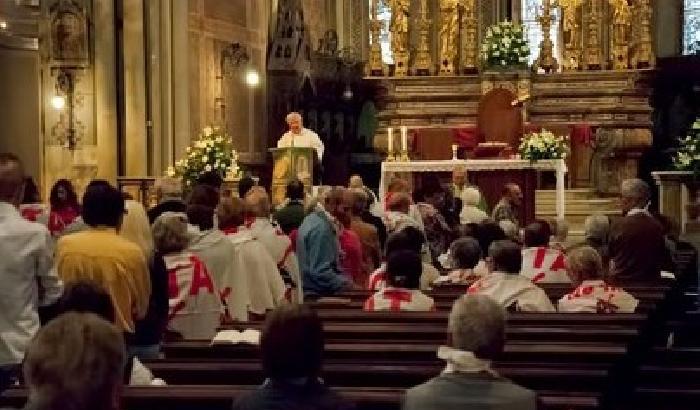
270,147,316,206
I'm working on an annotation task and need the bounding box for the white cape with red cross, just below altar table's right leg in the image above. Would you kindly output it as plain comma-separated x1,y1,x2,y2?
520,246,571,283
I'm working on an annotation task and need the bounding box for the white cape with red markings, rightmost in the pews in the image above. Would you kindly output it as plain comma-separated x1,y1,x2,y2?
558,280,639,313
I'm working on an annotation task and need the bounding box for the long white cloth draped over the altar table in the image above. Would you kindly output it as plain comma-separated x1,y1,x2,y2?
379,159,568,218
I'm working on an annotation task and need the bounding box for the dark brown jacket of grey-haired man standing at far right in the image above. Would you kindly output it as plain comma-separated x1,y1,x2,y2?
608,213,672,283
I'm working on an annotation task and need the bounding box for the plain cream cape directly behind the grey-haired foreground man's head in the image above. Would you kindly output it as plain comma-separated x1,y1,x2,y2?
467,272,556,312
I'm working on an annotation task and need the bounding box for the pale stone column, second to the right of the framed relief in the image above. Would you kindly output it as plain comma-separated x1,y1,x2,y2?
123,0,149,176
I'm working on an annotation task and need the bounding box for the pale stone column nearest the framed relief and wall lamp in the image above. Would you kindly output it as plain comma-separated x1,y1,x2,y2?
93,1,118,182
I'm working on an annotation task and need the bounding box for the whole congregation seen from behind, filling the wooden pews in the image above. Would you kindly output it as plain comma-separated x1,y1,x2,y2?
0,148,692,409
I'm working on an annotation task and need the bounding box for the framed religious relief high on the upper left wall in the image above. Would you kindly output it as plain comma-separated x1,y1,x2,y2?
48,0,89,67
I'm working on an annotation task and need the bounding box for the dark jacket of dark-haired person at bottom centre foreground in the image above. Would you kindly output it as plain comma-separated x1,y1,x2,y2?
233,380,354,410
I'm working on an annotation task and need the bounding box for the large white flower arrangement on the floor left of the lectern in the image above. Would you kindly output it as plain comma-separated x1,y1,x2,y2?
166,127,239,186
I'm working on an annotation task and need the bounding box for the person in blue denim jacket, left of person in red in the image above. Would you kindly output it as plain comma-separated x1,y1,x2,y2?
297,188,352,297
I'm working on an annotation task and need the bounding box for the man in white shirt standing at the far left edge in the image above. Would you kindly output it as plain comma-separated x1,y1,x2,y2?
0,153,63,391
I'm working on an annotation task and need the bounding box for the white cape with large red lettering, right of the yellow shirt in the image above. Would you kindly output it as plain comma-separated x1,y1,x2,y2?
163,252,223,339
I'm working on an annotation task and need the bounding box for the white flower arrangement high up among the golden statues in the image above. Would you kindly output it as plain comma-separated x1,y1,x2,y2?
481,21,530,68
